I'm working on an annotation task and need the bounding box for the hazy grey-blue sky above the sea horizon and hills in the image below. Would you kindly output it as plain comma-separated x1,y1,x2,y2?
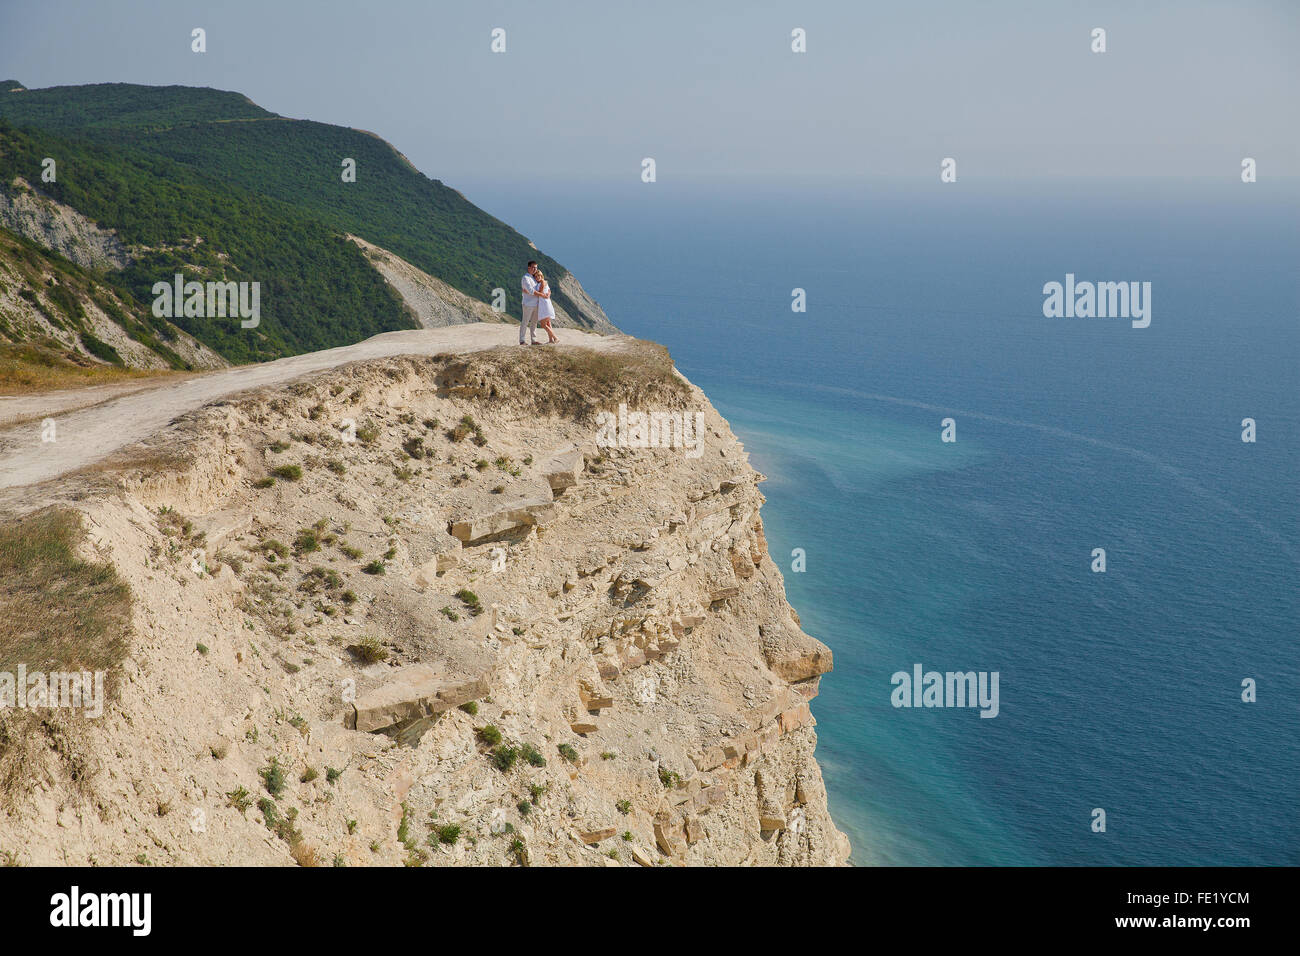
0,0,1300,185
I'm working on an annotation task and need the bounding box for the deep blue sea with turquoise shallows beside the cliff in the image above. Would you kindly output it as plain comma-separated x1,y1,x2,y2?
458,182,1300,865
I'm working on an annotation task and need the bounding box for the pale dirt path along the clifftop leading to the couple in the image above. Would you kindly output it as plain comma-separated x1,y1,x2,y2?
0,323,625,489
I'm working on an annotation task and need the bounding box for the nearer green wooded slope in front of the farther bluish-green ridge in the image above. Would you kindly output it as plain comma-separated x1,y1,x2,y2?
0,115,413,362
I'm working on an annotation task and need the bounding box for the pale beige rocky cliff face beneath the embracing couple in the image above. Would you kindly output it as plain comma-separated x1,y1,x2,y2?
0,339,848,866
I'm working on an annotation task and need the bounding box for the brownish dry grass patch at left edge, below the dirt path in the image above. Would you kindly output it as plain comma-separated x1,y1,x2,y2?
0,509,131,805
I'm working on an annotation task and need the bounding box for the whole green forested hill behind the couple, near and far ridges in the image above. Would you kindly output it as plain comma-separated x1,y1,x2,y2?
0,81,610,362
